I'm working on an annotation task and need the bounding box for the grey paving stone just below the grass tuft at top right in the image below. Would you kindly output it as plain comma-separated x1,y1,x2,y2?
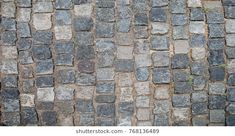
206,11,224,24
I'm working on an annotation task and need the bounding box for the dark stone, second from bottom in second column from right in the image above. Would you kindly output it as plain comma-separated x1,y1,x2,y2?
209,95,226,109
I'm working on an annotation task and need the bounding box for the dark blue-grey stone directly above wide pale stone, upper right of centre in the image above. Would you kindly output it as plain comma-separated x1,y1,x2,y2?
150,8,167,22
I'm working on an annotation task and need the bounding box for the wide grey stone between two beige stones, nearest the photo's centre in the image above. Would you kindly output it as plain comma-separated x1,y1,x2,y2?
114,59,134,72
